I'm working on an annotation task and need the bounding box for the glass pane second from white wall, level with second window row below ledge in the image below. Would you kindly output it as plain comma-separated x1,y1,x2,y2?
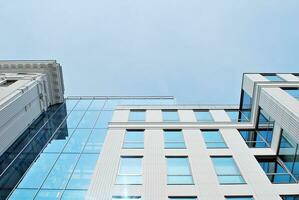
42,154,79,189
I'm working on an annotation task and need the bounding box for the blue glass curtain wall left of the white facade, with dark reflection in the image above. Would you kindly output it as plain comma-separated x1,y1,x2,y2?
0,97,175,199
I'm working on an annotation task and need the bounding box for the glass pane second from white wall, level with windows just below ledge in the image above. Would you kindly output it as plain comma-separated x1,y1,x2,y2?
63,129,91,153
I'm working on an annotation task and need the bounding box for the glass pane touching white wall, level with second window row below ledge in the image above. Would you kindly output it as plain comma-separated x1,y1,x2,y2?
67,154,99,189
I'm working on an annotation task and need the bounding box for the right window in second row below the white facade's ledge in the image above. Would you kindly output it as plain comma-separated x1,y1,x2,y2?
211,156,245,184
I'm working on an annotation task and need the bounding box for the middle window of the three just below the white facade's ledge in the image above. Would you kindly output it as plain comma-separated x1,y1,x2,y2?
164,130,186,149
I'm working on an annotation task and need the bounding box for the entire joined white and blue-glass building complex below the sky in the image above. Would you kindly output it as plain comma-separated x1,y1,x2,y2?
0,61,299,200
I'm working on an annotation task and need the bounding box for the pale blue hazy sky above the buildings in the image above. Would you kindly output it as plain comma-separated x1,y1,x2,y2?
0,0,299,104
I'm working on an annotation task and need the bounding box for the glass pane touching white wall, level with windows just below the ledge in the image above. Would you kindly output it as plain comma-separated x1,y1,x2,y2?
83,129,107,153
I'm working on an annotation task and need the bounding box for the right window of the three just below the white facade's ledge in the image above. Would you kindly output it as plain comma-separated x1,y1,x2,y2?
201,130,227,149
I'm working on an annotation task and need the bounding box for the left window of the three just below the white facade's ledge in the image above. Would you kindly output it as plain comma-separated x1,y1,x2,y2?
123,130,144,149
